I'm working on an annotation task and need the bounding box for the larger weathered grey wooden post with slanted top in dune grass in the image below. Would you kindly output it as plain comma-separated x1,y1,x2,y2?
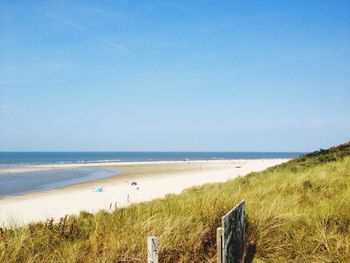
217,200,245,263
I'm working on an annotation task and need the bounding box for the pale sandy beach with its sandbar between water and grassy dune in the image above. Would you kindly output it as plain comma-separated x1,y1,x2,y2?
0,159,287,226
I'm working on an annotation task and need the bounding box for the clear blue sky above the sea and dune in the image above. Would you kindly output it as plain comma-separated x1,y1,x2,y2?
0,0,350,151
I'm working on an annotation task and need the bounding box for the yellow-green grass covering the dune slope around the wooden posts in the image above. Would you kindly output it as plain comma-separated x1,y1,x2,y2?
0,143,350,262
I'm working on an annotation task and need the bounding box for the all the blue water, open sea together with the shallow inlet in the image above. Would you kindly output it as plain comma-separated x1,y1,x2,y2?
0,152,304,198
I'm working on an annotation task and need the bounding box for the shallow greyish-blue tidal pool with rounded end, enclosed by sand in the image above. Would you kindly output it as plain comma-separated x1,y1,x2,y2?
0,168,120,196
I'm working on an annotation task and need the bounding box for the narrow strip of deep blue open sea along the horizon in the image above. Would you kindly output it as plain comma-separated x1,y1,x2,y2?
0,152,303,166
